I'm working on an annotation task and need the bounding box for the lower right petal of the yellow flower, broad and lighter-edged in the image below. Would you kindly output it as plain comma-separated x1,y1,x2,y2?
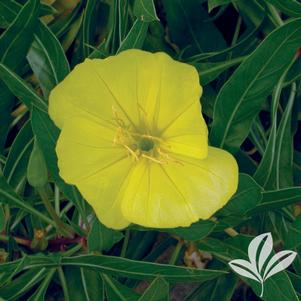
122,147,238,228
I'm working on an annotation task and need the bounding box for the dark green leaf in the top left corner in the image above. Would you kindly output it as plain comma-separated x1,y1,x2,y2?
0,0,40,69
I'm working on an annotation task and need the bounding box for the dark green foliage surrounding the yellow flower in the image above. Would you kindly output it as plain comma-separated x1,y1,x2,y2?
0,0,301,301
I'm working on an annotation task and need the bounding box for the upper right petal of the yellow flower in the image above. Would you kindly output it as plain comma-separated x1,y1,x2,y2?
138,52,208,159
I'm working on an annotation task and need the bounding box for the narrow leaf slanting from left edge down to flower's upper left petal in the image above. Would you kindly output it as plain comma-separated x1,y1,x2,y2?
0,63,47,111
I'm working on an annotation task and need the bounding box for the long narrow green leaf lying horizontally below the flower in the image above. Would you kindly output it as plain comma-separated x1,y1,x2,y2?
4,255,226,283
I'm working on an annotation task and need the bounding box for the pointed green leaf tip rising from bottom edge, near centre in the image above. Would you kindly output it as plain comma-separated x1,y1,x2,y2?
139,277,170,301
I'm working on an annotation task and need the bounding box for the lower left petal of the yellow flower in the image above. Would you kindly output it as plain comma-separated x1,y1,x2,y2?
56,117,132,229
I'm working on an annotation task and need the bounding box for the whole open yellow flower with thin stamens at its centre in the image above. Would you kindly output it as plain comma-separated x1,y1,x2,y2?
49,50,238,229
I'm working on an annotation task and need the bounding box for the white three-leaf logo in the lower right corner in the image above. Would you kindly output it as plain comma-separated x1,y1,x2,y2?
229,233,297,297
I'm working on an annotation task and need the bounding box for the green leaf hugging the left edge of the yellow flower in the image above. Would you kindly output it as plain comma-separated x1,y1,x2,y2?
31,107,82,210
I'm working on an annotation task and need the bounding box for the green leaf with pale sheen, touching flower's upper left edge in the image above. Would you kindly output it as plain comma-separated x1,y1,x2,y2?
27,22,70,98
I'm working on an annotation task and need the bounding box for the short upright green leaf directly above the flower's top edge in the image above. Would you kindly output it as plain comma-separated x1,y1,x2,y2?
117,19,148,53
